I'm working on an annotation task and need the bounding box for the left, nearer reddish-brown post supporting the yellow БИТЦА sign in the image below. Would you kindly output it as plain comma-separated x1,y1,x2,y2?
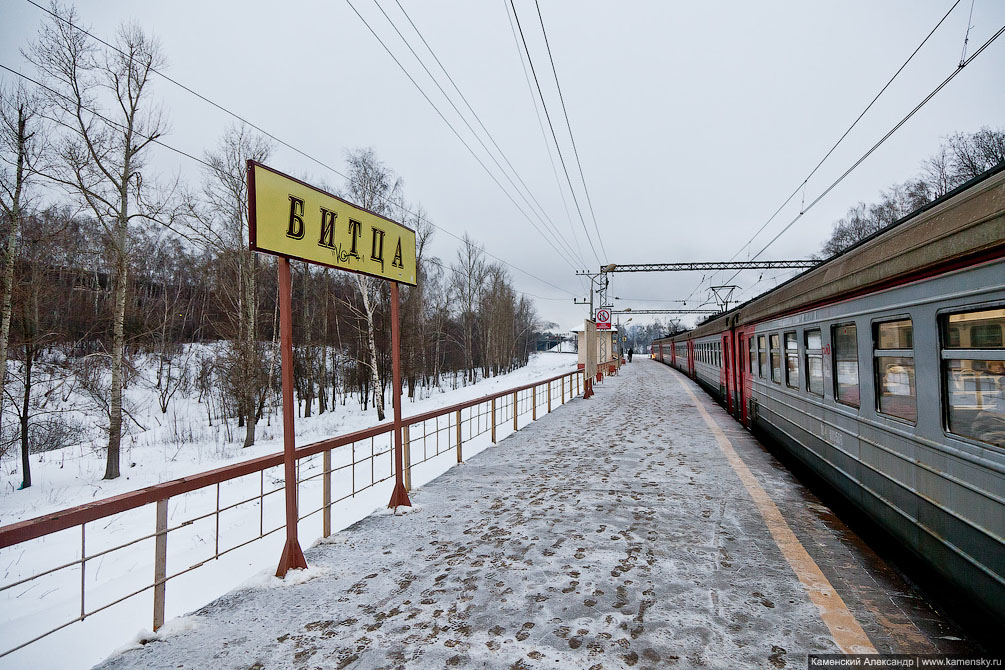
275,258,308,577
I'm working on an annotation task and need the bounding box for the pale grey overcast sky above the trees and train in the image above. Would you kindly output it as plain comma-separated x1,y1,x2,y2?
0,0,1005,328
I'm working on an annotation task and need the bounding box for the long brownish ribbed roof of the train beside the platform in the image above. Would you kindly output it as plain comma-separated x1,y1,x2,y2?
657,162,1005,342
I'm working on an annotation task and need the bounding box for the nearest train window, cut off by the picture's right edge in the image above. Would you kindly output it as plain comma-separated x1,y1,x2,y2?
942,309,1005,447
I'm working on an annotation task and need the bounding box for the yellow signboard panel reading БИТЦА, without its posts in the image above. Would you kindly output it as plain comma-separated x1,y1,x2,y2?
248,161,415,286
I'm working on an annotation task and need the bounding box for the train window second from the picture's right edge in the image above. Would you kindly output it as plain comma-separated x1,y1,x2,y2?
873,318,918,422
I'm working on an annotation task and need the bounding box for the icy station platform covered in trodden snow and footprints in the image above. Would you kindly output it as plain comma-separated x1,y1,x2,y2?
101,360,969,669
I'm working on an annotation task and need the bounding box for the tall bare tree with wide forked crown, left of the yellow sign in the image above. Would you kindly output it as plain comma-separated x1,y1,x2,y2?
26,3,165,479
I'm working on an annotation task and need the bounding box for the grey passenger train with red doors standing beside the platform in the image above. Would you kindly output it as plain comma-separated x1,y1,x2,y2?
654,164,1005,626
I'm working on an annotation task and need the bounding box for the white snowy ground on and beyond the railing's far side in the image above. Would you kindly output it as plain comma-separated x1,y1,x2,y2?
0,354,576,668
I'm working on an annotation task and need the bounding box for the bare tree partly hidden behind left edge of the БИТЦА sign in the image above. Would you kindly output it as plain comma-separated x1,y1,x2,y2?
187,126,272,447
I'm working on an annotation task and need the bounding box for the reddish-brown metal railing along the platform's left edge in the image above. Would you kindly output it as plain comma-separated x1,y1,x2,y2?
0,370,583,659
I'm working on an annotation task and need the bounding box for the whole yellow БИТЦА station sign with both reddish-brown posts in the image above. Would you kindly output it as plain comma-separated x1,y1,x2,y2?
247,161,416,577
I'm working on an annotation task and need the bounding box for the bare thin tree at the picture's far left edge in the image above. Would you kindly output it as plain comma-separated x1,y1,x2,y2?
0,85,44,401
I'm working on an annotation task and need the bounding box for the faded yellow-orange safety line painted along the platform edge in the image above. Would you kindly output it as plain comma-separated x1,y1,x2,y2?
674,375,877,654
